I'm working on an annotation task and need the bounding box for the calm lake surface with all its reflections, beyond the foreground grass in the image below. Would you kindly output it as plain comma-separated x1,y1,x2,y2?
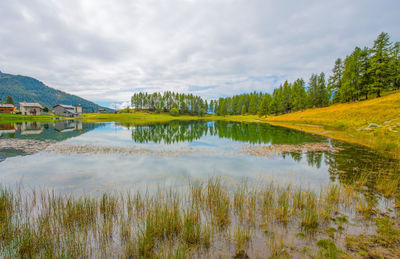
0,121,396,196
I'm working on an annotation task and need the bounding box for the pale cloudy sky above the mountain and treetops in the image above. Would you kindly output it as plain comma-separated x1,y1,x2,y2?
0,0,400,108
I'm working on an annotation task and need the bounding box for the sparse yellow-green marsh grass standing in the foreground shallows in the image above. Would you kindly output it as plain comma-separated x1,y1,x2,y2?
0,177,400,258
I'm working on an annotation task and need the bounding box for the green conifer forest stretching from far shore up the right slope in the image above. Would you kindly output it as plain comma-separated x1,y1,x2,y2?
132,32,400,116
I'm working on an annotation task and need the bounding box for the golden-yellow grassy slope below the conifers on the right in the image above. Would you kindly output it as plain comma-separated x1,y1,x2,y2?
262,92,400,156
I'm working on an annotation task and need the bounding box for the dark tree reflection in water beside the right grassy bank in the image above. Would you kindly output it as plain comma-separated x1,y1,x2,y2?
270,140,400,198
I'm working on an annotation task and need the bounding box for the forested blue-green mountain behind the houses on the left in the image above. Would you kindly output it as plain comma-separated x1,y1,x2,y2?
0,71,112,112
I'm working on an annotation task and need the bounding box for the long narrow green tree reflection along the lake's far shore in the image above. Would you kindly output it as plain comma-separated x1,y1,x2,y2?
132,121,326,144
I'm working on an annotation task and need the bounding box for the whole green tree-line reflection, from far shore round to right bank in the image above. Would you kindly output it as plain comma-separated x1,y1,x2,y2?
132,121,400,198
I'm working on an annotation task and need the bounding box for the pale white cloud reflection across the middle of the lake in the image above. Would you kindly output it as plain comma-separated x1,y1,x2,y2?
0,123,336,196
